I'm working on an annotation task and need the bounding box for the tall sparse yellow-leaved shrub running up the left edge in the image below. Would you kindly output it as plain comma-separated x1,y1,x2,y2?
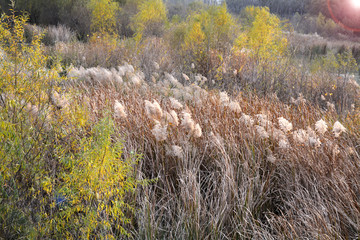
0,7,60,239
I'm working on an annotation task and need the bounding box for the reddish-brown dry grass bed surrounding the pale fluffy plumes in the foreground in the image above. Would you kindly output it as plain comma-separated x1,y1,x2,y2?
69,65,360,239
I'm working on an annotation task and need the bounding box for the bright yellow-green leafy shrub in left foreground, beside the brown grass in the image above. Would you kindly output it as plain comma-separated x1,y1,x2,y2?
51,118,136,239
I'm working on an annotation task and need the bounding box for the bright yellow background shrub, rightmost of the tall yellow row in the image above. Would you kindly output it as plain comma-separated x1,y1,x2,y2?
234,7,289,93
